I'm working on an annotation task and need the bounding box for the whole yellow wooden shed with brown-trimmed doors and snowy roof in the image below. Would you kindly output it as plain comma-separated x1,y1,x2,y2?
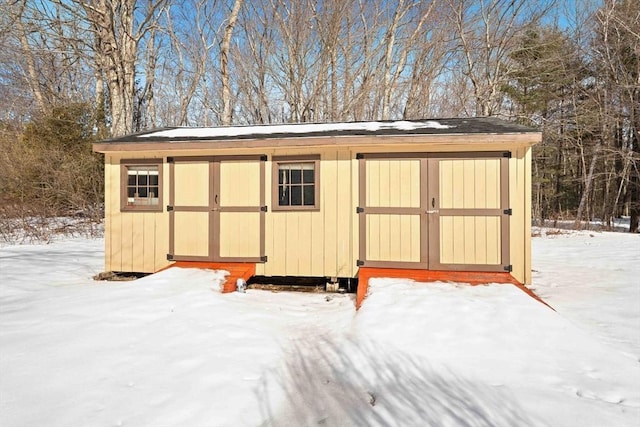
94,118,541,302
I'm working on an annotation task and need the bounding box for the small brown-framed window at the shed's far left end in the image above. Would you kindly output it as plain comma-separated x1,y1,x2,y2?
120,159,162,211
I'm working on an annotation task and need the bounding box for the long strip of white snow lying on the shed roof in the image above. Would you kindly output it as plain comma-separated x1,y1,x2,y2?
138,120,454,138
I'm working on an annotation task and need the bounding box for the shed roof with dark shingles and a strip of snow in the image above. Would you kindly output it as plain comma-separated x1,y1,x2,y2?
94,117,540,152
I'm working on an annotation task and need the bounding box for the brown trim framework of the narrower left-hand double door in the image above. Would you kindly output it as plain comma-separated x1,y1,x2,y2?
167,154,267,263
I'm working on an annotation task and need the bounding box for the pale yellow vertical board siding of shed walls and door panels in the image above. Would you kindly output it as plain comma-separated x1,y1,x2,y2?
105,140,531,283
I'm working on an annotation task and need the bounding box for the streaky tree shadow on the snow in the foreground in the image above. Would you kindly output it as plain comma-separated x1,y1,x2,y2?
256,336,541,427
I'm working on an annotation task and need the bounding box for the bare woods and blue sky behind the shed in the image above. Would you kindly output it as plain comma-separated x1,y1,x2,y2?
0,0,640,232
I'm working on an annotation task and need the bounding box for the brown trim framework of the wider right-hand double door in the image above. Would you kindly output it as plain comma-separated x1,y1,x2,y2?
356,151,511,272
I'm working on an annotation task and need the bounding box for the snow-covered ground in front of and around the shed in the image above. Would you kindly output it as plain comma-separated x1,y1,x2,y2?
0,232,640,427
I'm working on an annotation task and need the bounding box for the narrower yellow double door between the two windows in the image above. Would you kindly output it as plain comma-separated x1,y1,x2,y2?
167,156,267,262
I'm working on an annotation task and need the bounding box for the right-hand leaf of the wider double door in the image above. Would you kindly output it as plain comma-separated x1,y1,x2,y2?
427,153,511,271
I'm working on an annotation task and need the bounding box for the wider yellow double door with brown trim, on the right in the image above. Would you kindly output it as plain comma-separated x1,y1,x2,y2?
358,152,511,271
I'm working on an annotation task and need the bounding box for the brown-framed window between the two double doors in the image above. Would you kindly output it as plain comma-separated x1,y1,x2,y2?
273,156,320,210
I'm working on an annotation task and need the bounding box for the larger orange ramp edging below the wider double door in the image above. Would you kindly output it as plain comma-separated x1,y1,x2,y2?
356,267,553,310
